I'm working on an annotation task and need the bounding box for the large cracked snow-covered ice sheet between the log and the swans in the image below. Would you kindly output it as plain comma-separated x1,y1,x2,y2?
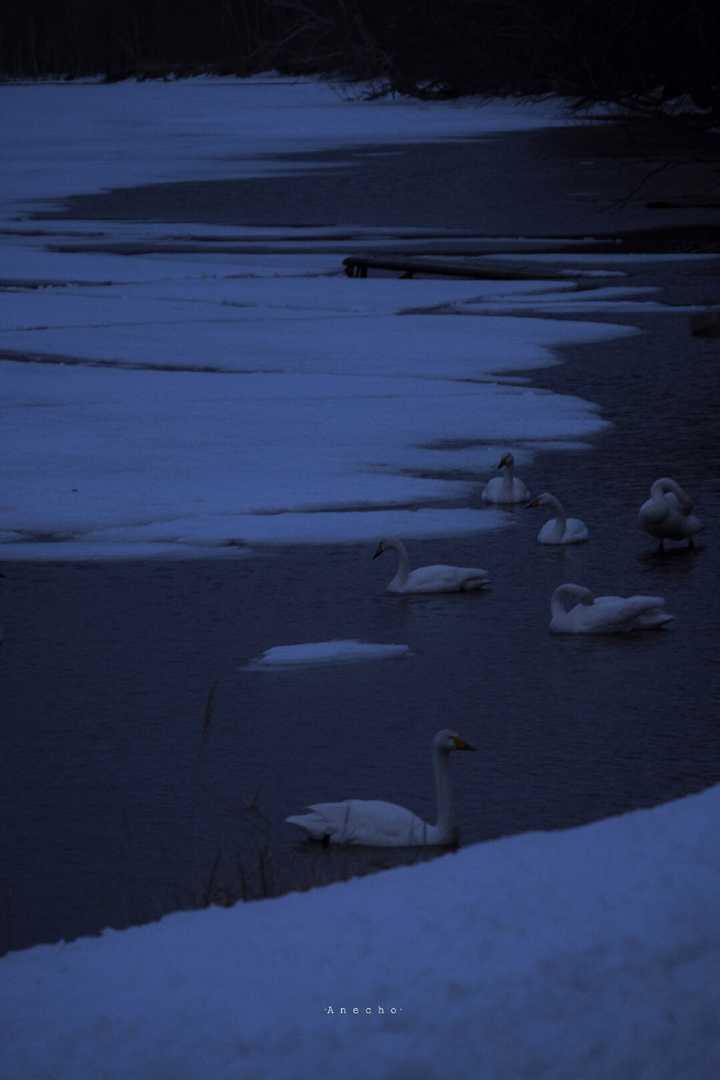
0,268,636,558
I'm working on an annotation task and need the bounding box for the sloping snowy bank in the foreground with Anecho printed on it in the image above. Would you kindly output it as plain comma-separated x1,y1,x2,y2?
0,787,720,1080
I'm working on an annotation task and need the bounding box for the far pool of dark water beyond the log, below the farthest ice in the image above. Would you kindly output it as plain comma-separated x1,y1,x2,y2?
52,123,720,234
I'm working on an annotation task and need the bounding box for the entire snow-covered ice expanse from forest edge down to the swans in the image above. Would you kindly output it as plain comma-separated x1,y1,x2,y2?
0,78,649,558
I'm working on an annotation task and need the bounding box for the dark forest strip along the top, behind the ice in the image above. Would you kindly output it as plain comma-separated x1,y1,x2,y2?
0,0,720,125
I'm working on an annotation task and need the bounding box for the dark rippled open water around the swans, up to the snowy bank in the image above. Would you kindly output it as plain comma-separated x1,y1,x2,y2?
0,128,720,948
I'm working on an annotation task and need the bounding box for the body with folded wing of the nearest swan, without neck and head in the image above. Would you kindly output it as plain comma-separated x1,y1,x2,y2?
285,799,432,847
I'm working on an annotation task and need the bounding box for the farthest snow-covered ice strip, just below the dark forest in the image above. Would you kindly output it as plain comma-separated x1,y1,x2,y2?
0,77,568,217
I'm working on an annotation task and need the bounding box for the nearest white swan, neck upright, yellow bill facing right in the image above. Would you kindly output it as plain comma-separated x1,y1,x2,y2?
285,730,476,848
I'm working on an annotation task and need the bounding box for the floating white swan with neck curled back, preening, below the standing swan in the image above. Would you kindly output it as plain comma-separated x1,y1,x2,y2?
551,585,673,634
